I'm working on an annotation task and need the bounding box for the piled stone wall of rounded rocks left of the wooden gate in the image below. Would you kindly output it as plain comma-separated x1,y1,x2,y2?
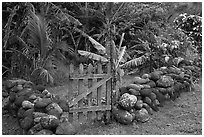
2,79,77,135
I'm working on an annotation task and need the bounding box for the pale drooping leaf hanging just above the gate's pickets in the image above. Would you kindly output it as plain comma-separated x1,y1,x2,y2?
78,50,108,63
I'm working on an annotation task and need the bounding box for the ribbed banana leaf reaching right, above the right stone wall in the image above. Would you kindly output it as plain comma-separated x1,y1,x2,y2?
120,54,149,69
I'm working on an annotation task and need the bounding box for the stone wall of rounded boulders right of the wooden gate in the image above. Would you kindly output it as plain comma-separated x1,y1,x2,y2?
112,67,191,124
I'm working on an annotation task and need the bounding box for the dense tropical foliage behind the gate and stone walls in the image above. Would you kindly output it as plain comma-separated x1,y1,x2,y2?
2,2,202,84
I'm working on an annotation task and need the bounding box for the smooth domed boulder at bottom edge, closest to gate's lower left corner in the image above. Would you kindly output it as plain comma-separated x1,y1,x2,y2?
55,122,77,135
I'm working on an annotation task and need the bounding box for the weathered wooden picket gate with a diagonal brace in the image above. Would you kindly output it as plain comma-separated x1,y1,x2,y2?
48,63,112,122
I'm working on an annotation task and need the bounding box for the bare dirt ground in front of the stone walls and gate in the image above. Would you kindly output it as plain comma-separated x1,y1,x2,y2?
2,78,202,135
